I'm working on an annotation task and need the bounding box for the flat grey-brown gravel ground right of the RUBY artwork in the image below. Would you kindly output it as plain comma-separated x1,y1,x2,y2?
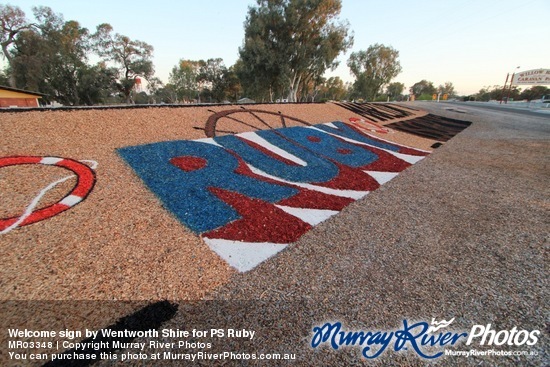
129,103,550,366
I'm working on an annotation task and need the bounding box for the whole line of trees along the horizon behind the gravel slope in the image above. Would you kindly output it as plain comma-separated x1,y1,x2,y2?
0,0,472,105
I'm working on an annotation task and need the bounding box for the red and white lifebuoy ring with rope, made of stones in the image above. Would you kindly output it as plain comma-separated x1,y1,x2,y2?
0,156,97,234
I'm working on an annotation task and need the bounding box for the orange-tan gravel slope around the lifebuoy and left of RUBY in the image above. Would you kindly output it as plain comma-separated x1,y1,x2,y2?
0,104,432,364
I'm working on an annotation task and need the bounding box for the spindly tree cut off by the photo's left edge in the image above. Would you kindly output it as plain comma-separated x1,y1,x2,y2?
0,4,31,87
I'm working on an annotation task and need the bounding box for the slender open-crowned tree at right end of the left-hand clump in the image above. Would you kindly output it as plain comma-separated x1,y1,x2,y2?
93,23,154,103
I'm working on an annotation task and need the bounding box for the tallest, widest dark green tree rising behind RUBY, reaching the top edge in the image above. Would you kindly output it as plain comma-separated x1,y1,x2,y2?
237,0,353,101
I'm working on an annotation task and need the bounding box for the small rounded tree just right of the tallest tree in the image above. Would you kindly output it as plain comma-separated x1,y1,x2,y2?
348,43,401,100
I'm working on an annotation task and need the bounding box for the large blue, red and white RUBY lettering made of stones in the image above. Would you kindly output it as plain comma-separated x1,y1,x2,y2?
118,119,429,271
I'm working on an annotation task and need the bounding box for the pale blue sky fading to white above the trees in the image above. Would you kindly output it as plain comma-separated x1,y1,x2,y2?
5,0,550,95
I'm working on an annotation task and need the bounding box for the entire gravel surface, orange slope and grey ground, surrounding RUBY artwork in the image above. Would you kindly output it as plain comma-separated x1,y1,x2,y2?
0,104,550,366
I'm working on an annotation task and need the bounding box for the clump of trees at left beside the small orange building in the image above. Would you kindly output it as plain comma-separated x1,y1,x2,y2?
0,4,154,105
